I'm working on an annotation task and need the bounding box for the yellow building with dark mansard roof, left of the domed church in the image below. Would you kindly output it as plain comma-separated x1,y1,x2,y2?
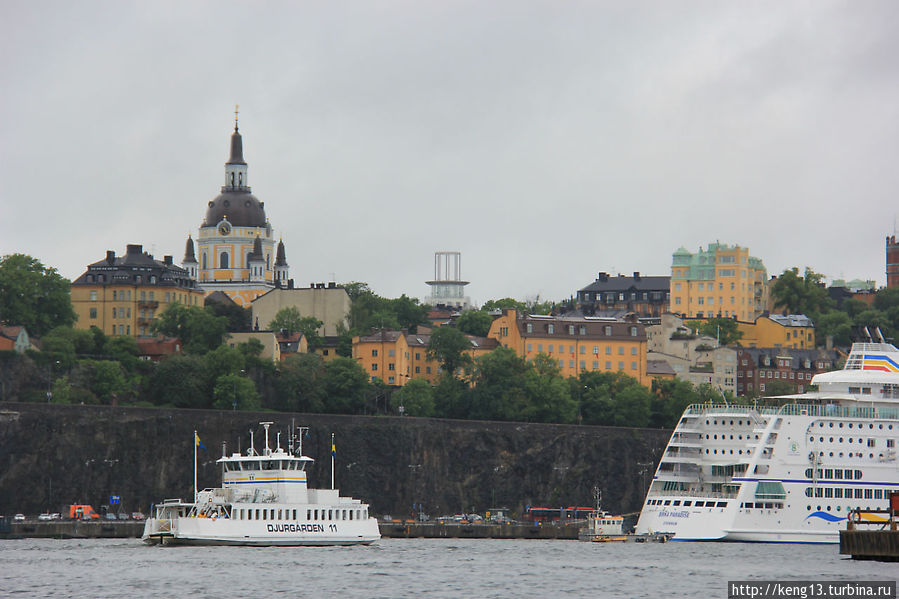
71,245,204,337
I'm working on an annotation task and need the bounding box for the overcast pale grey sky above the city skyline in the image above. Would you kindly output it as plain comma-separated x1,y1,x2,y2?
0,0,899,303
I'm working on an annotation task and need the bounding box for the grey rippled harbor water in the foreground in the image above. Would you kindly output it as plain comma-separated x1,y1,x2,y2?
0,539,899,599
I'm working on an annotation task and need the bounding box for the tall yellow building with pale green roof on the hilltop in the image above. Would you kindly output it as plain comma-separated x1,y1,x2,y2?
670,243,768,322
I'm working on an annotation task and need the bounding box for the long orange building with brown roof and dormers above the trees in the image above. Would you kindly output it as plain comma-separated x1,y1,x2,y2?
488,309,652,386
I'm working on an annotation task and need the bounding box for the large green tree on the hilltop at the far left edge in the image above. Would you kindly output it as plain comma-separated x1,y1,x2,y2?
0,254,76,337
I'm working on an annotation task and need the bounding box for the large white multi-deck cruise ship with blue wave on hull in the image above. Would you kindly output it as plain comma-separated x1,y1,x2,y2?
636,343,899,543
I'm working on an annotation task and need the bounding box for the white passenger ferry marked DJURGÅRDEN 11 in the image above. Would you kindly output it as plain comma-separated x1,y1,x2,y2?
142,422,381,546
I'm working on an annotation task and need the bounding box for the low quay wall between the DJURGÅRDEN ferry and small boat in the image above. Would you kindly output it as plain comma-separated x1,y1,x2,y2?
378,520,585,541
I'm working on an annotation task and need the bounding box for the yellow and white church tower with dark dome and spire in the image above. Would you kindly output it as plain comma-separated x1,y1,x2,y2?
193,110,287,307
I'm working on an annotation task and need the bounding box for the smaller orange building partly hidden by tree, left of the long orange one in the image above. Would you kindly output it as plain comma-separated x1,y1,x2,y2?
353,330,498,387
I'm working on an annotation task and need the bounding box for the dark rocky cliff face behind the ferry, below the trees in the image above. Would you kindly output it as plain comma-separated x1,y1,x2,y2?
0,403,670,517
